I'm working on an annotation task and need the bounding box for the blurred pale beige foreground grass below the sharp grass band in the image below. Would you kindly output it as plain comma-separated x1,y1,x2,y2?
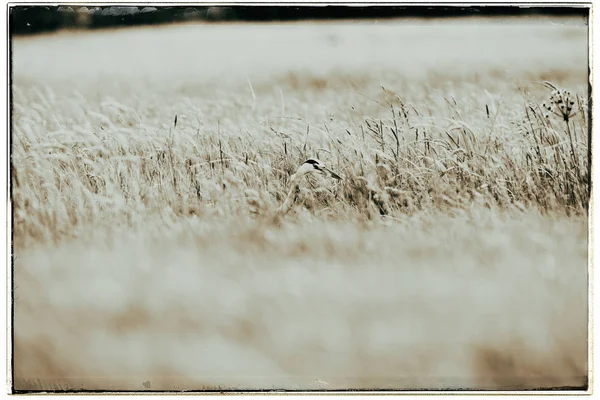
14,210,587,390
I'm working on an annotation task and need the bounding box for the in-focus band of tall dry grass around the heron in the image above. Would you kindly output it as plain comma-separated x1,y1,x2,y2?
11,73,590,245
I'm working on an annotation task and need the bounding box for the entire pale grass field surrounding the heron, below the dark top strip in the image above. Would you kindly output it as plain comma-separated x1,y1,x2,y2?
11,18,590,390
